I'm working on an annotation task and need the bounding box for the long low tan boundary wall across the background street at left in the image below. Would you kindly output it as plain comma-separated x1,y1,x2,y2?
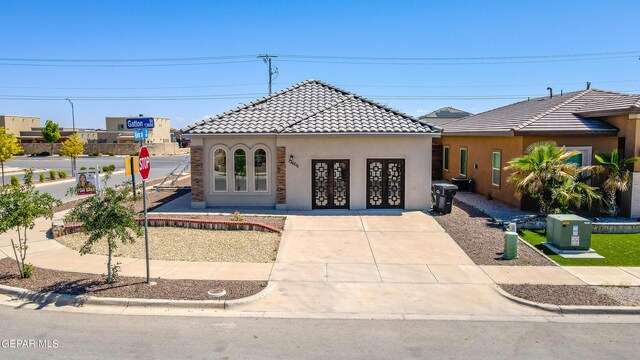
20,143,189,155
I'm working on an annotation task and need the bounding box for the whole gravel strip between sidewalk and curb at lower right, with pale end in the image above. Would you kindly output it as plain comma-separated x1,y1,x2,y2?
500,284,640,306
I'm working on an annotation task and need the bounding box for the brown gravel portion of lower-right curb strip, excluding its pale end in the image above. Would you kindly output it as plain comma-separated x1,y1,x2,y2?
500,284,621,306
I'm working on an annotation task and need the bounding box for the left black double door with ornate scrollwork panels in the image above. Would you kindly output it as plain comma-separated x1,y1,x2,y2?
311,160,349,209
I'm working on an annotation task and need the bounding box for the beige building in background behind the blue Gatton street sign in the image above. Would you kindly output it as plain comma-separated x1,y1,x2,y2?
104,116,171,144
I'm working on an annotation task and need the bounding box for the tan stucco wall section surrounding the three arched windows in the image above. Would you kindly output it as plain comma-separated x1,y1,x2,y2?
201,135,276,207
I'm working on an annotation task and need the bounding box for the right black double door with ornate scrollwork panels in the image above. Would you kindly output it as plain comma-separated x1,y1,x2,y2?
367,159,404,209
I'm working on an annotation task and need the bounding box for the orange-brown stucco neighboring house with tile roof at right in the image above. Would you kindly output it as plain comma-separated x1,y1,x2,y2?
435,89,640,217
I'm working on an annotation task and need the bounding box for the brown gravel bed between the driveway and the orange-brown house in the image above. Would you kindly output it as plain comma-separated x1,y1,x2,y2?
431,202,554,266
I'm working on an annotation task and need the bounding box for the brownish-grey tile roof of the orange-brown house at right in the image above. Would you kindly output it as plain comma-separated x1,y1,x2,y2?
440,89,621,136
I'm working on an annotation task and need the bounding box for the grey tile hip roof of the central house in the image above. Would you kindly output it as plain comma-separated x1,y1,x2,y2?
183,80,438,134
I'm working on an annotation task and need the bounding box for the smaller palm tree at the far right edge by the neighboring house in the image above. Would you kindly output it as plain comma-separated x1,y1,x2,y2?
594,149,640,217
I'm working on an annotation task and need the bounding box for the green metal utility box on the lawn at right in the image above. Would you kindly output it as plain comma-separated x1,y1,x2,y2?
547,215,591,250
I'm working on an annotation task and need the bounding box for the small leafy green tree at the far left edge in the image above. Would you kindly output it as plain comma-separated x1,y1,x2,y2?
0,186,61,278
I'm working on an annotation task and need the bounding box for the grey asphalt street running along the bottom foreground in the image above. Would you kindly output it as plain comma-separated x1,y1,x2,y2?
0,306,640,360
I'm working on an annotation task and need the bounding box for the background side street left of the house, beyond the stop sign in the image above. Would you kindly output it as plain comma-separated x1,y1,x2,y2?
5,155,189,201
